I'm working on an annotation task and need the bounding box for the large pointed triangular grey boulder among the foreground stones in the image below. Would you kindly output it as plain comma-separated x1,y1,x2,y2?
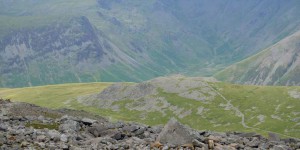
157,118,194,146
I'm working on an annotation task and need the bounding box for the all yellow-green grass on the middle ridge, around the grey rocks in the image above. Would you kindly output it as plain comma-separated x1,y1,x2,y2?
0,82,300,138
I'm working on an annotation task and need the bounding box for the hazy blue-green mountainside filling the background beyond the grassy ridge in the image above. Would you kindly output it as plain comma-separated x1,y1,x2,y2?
0,0,300,87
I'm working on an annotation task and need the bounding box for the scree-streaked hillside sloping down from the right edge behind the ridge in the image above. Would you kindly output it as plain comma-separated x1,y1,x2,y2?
215,31,300,85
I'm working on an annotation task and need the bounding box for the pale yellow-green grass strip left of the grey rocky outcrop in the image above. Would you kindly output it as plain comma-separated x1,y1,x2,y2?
0,82,113,109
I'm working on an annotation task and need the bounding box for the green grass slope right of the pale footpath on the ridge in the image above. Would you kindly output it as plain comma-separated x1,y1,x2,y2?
212,82,300,138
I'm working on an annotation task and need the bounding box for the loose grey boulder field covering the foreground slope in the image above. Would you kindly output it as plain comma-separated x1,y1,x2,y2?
0,99,300,150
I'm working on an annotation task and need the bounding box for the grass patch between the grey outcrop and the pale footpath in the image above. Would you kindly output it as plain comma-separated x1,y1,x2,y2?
159,90,245,131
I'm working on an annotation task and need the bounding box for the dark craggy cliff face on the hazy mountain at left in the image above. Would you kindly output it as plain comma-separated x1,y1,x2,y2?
0,17,106,86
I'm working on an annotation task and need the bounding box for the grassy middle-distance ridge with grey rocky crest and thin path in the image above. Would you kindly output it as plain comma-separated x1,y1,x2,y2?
0,76,300,138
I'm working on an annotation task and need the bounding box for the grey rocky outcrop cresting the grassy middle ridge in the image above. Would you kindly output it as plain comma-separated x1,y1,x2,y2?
77,75,217,118
